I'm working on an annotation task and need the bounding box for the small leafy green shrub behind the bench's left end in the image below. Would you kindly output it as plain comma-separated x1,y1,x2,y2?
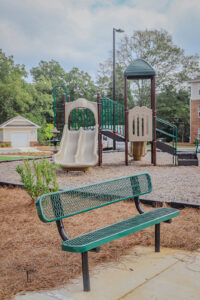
16,159,59,202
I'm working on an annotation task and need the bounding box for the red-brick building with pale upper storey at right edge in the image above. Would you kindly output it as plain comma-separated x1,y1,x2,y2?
189,77,200,143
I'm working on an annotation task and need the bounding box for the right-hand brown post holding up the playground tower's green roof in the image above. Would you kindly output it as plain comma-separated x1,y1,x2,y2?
151,76,156,166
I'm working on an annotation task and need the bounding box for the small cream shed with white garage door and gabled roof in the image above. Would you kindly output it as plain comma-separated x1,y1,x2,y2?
0,116,40,147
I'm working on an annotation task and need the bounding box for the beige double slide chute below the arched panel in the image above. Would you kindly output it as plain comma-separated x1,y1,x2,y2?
53,124,98,169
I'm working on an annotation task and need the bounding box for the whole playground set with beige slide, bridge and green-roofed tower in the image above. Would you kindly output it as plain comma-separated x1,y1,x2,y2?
55,59,198,167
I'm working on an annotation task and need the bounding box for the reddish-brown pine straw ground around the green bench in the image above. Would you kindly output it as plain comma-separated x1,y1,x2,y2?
0,187,200,299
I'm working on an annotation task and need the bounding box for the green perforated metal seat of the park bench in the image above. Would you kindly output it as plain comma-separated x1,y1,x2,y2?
62,207,178,253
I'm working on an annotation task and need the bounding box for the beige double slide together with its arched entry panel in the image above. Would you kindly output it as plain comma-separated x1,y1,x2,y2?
53,98,98,169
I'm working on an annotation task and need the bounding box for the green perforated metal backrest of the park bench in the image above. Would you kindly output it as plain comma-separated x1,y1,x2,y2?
36,173,152,222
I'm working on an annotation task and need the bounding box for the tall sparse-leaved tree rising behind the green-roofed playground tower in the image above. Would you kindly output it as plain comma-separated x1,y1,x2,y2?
98,30,200,106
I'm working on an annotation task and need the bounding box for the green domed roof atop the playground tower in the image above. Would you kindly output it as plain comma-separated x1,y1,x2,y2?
124,59,156,79
